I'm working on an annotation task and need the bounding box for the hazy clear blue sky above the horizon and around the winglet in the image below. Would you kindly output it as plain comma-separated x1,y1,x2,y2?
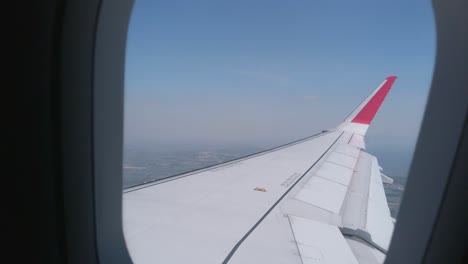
125,0,435,177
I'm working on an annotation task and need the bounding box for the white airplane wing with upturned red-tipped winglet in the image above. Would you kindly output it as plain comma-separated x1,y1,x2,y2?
123,76,396,264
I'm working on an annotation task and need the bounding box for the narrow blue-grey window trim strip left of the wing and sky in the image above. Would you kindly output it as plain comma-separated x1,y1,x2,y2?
93,0,133,263
